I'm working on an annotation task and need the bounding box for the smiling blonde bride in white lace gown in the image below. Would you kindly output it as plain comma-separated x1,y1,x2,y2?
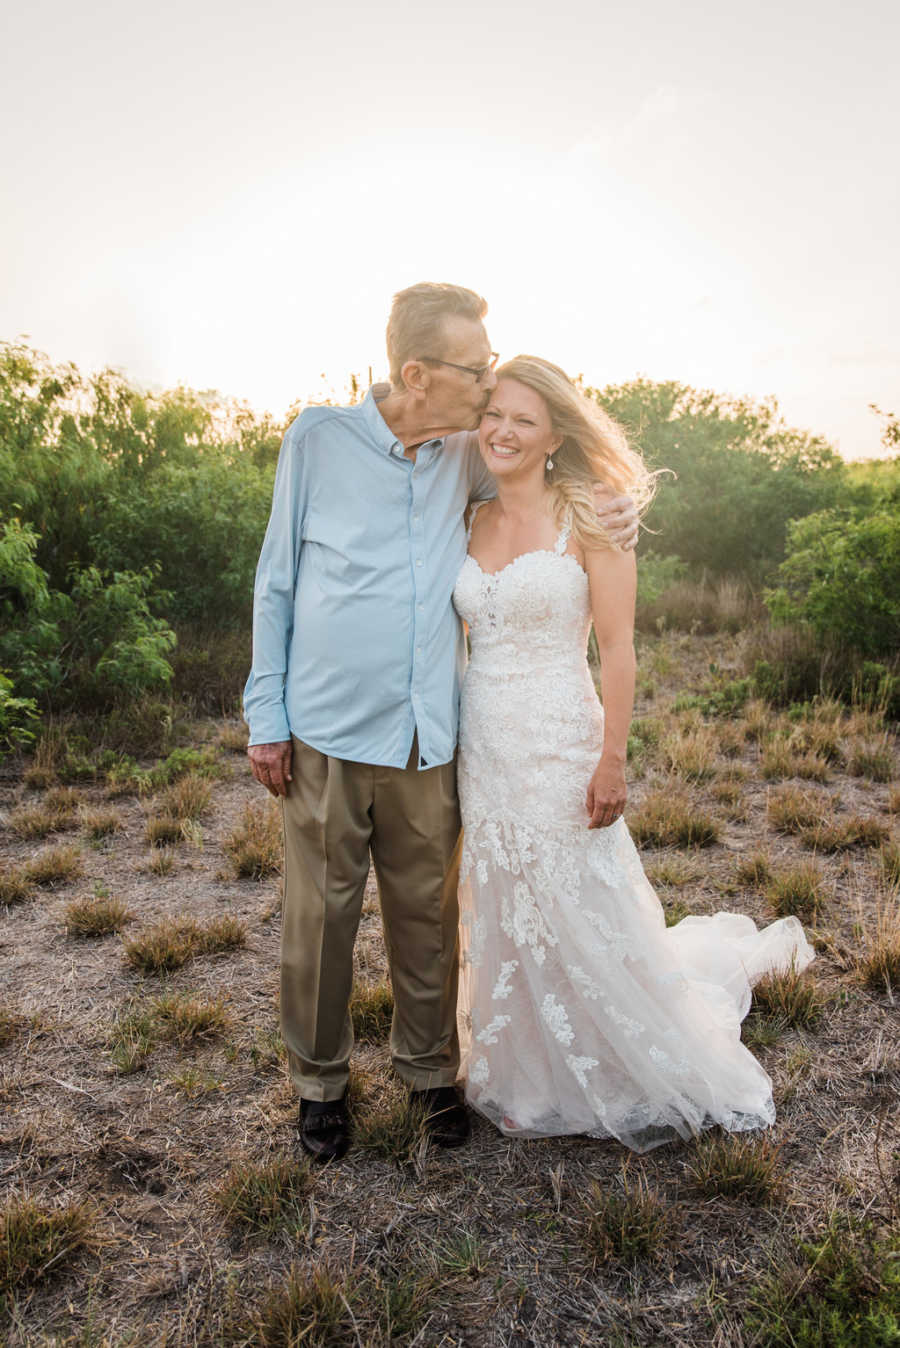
454,356,812,1151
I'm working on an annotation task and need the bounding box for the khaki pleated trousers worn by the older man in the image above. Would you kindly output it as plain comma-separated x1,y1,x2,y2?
282,739,462,1100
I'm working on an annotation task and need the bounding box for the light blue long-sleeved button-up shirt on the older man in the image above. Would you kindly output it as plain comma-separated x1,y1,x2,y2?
244,386,496,767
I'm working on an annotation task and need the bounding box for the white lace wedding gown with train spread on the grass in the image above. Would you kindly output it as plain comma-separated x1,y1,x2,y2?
454,509,814,1151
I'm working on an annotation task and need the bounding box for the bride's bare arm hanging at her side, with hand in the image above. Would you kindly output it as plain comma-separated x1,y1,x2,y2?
585,547,637,829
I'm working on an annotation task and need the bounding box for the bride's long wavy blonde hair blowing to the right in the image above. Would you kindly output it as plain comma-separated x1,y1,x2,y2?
496,356,656,547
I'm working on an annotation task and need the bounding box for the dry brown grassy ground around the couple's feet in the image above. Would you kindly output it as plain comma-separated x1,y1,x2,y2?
0,634,900,1348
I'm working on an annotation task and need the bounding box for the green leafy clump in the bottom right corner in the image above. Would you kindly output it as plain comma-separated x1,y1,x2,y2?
746,1217,900,1348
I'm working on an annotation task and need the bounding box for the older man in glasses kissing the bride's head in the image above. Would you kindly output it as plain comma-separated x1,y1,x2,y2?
244,283,636,1161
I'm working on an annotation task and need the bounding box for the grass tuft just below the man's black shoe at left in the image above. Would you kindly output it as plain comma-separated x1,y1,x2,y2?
213,1157,313,1237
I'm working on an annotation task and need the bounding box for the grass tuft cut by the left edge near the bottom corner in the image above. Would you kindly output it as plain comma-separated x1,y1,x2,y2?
0,1194,96,1297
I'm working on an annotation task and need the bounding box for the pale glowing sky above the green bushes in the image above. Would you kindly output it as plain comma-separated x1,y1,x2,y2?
0,0,900,457
